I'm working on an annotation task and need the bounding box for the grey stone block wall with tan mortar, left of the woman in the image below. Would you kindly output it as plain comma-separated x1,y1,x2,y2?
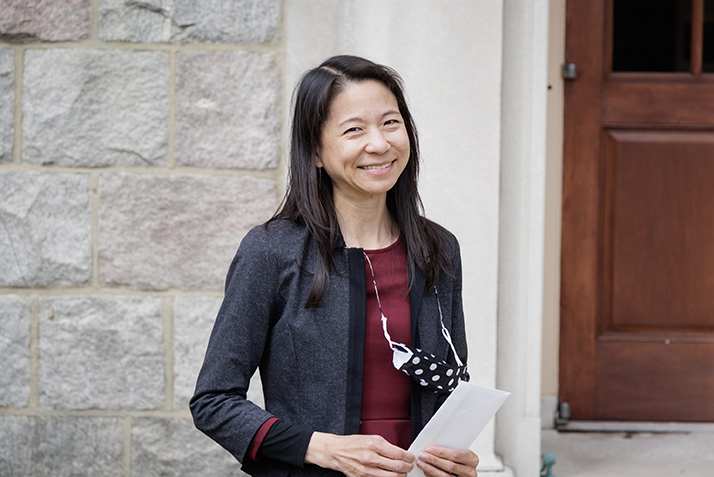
0,0,285,476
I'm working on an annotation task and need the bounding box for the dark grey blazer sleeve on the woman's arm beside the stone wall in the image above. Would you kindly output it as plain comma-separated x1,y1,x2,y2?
189,227,279,462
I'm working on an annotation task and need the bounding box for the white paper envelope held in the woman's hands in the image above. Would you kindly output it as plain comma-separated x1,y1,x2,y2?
408,381,511,477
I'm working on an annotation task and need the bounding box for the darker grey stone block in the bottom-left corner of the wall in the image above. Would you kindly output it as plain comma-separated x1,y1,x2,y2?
0,416,124,477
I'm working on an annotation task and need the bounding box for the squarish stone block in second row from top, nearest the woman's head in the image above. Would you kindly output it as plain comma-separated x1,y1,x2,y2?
176,51,281,169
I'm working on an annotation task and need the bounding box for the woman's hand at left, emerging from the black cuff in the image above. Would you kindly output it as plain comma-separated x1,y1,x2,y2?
305,432,415,477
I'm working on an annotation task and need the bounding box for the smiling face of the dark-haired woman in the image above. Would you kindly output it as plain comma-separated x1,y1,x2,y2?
316,80,409,202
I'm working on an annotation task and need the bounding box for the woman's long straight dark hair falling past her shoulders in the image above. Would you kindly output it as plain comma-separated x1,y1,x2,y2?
269,56,451,308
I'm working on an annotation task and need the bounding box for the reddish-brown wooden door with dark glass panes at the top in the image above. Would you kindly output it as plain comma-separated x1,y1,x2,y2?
559,0,714,421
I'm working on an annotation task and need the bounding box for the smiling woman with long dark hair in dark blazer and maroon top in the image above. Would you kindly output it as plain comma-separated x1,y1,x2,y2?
191,56,478,477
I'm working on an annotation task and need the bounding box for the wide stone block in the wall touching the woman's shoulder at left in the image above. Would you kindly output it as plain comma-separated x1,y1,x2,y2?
99,173,277,290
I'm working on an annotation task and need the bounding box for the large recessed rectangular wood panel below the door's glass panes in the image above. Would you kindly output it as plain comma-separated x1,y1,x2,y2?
602,130,714,330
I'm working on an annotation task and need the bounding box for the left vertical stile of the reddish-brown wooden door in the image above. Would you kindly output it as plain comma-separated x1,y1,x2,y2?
558,1,605,419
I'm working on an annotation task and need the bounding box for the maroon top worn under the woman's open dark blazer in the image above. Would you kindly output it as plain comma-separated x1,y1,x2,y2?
359,236,412,449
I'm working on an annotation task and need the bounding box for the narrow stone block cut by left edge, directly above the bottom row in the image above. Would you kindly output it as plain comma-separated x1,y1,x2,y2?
0,295,30,407
